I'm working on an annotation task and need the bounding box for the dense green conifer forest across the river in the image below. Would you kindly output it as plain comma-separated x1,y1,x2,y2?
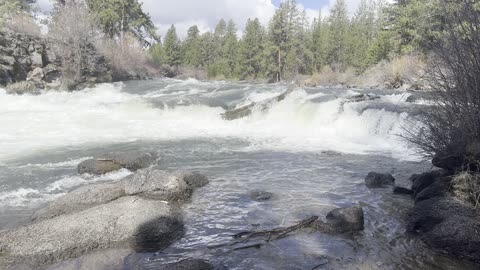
150,0,439,81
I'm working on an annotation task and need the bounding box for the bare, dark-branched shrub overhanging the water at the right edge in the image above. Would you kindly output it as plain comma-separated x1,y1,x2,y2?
406,0,480,166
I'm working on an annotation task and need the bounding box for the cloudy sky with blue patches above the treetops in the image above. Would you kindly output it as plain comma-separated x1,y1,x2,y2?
37,0,361,38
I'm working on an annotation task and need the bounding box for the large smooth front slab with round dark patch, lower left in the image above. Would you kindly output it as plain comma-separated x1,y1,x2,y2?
0,196,184,268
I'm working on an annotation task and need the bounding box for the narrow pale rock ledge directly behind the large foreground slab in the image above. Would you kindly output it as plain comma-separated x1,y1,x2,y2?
32,183,125,221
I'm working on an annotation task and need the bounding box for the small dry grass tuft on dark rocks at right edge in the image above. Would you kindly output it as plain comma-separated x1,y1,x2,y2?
452,172,480,208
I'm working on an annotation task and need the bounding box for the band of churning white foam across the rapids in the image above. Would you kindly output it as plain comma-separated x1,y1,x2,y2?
0,79,420,161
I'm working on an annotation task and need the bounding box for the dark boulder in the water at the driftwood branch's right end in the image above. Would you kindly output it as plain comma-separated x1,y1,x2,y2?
314,206,365,234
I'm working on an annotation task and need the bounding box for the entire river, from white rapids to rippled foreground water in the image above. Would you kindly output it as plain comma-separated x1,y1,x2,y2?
0,79,474,270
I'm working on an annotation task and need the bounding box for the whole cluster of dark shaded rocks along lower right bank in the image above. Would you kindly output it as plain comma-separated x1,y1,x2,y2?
407,170,480,262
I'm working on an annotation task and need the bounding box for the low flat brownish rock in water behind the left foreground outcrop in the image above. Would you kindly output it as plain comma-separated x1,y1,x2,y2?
77,152,157,175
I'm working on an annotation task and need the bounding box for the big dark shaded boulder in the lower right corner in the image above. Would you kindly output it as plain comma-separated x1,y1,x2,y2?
407,196,480,262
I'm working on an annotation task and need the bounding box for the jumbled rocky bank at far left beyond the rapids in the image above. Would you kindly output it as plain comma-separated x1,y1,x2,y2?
0,31,145,94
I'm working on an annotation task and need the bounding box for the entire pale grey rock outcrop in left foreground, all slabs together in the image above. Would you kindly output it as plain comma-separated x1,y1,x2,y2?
0,168,208,269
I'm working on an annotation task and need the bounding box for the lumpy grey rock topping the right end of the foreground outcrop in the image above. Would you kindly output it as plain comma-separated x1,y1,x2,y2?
122,168,193,201
